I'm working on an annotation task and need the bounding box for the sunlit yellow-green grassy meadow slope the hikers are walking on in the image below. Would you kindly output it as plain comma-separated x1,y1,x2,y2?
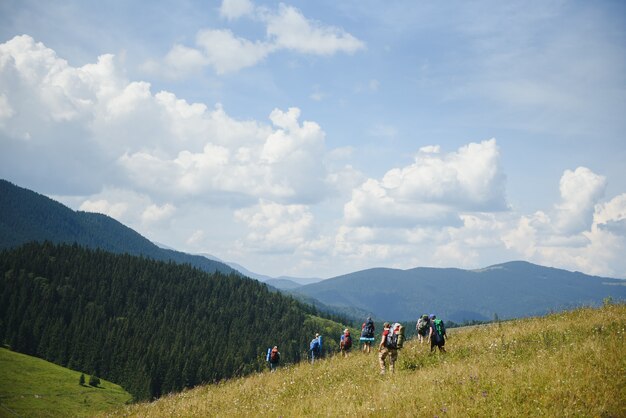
104,304,626,417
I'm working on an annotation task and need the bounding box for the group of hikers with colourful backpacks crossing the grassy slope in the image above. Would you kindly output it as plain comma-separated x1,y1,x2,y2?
266,314,447,374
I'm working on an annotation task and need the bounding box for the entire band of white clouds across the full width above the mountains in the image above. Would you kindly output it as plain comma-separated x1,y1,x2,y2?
0,34,626,275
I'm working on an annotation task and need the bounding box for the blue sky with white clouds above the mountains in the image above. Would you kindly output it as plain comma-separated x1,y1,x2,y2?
0,0,626,278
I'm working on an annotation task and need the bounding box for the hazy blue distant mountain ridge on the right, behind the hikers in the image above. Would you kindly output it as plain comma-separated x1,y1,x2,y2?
293,261,626,322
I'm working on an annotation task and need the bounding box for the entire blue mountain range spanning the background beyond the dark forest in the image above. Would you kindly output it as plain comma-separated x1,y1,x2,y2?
0,180,626,322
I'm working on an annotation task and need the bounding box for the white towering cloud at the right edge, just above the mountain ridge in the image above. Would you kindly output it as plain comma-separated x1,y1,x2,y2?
502,167,626,276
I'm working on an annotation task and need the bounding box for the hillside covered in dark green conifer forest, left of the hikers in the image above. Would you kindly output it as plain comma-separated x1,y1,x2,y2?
0,242,342,399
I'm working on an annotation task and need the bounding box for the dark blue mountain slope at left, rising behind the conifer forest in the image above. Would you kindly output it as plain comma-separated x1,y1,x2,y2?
0,179,235,274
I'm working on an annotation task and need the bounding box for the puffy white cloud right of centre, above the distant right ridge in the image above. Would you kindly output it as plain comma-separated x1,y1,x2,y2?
344,139,507,226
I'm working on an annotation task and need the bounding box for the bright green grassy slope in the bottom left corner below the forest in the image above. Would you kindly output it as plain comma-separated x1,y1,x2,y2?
0,348,132,417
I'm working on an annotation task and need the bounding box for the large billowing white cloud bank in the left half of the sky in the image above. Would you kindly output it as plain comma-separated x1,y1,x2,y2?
0,36,330,207
